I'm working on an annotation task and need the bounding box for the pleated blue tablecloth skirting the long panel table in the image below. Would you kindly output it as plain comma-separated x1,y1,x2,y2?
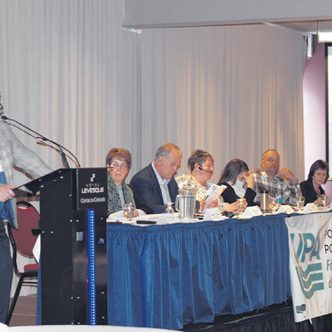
107,215,291,329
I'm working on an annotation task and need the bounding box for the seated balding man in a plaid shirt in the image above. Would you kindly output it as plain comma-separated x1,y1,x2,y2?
253,149,297,205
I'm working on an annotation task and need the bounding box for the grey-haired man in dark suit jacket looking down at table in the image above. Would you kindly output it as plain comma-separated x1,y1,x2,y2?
130,143,182,213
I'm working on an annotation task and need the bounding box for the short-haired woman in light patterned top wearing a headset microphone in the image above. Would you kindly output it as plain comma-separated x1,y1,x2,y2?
176,149,239,212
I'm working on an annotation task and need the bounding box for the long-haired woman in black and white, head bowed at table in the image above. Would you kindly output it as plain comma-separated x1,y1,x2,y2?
218,158,256,206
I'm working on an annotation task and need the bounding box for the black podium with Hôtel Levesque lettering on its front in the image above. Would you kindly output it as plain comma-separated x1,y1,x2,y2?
18,168,107,325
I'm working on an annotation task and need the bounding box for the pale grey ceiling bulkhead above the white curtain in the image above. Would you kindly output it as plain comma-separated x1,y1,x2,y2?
123,0,332,28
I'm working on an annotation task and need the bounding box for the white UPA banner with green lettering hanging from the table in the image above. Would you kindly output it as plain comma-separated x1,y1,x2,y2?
285,213,332,322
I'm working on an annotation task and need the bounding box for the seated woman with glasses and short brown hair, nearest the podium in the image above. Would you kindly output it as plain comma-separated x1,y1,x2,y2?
106,148,136,215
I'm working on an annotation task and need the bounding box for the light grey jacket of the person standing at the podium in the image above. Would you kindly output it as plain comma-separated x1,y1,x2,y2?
0,120,52,226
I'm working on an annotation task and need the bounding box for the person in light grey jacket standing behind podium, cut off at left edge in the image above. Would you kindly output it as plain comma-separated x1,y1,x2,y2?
0,120,52,323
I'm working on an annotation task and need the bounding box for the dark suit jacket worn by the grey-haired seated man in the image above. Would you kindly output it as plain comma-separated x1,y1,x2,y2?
130,164,179,213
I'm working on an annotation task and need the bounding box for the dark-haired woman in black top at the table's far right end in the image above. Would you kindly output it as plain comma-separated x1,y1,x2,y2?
300,159,329,205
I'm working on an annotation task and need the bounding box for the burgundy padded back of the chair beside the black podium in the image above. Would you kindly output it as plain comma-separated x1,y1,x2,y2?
11,201,40,258
